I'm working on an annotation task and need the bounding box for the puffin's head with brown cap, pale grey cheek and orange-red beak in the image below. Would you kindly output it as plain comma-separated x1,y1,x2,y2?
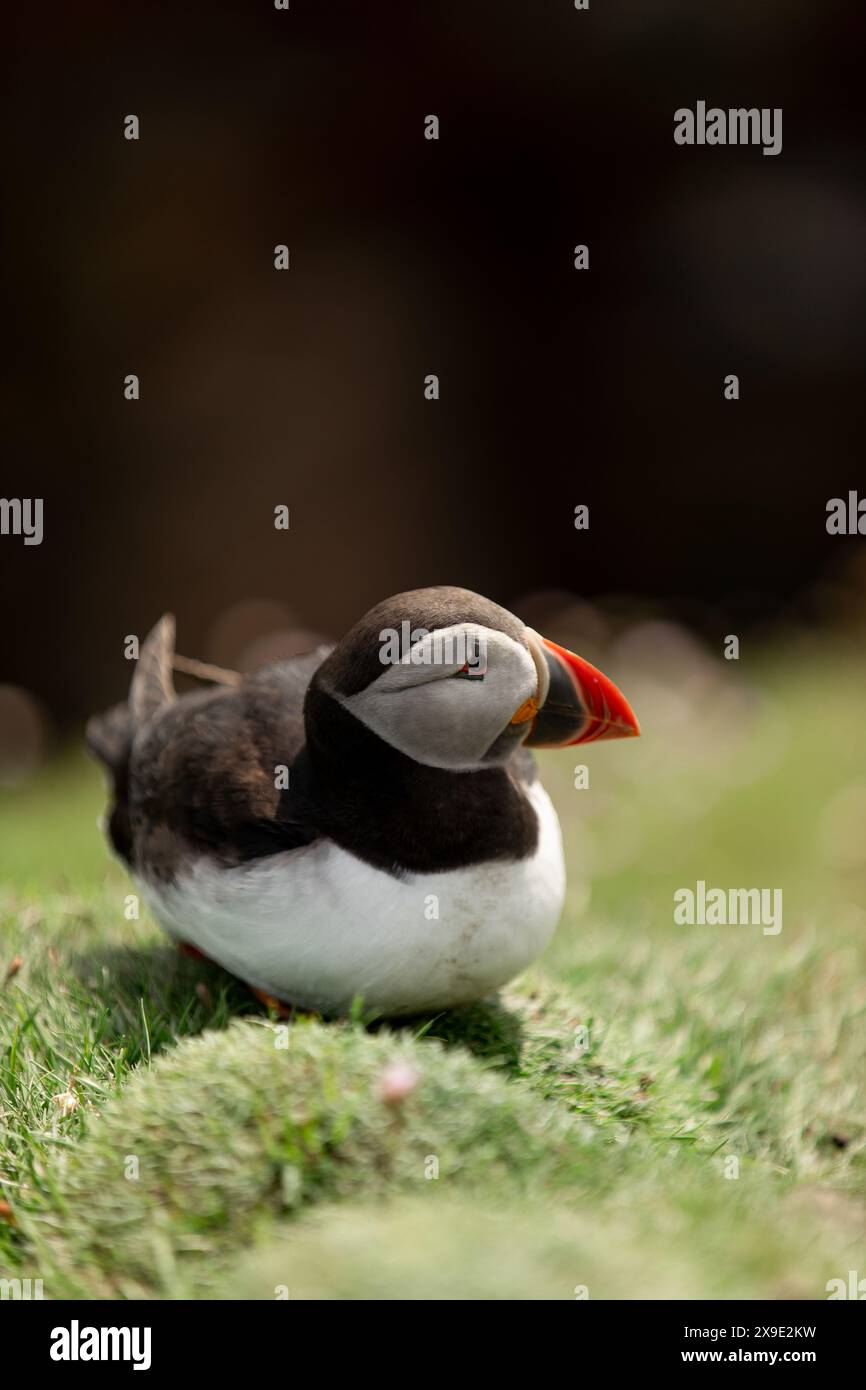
314,587,639,771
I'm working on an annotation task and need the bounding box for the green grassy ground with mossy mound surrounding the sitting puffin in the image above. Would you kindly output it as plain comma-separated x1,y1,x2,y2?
0,630,866,1298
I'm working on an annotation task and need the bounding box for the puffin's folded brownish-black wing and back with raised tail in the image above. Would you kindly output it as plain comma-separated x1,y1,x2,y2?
88,619,325,877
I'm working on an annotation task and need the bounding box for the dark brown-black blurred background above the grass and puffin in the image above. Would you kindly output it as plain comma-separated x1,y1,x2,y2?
0,0,866,745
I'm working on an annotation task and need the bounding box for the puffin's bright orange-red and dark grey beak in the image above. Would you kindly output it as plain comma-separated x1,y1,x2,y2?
524,632,641,748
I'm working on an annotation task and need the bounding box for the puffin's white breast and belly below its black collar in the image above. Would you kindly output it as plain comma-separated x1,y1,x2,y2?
143,781,566,1016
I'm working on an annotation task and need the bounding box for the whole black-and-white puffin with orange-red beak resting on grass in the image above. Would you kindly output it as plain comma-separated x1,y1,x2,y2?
86,585,639,1017
